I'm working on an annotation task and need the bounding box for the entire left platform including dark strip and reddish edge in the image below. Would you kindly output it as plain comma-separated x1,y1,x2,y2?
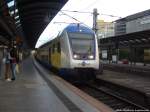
0,58,112,112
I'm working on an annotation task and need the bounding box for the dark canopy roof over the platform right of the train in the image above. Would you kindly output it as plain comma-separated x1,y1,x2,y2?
100,30,150,47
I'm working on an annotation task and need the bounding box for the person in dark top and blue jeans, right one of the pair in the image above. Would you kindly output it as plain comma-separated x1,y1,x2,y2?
10,46,17,80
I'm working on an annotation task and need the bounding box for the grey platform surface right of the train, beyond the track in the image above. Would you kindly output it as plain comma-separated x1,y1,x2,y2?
97,70,150,107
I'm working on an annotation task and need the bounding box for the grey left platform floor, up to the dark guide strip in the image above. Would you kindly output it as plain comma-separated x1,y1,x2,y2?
0,58,69,112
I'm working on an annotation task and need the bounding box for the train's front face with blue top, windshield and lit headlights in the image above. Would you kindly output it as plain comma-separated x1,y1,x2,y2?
68,26,99,70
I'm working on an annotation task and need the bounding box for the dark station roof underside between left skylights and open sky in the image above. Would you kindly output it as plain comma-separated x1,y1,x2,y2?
5,0,68,48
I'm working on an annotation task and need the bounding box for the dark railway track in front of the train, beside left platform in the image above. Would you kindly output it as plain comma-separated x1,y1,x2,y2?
77,83,149,112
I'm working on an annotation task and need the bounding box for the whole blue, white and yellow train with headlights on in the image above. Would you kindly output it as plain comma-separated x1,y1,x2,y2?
36,24,102,78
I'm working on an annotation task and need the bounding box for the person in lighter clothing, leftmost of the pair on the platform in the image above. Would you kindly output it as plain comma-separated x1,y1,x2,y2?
4,48,11,81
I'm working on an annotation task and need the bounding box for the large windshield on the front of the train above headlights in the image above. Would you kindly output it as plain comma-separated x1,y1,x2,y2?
69,33,94,54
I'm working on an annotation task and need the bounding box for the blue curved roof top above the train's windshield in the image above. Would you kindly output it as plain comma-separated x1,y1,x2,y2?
64,24,94,34
